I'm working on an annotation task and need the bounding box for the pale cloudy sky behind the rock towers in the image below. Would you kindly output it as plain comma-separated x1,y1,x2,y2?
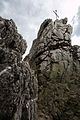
0,0,80,53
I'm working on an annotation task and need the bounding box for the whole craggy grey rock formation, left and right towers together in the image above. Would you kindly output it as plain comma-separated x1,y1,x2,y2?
0,17,80,120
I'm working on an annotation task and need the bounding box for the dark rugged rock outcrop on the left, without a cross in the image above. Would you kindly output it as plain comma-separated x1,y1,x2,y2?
0,17,37,120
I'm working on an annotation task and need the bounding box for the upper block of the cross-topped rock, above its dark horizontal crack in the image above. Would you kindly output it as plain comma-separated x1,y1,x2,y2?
30,17,72,59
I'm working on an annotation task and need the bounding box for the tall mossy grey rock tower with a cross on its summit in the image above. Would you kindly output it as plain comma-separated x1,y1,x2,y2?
25,18,80,120
